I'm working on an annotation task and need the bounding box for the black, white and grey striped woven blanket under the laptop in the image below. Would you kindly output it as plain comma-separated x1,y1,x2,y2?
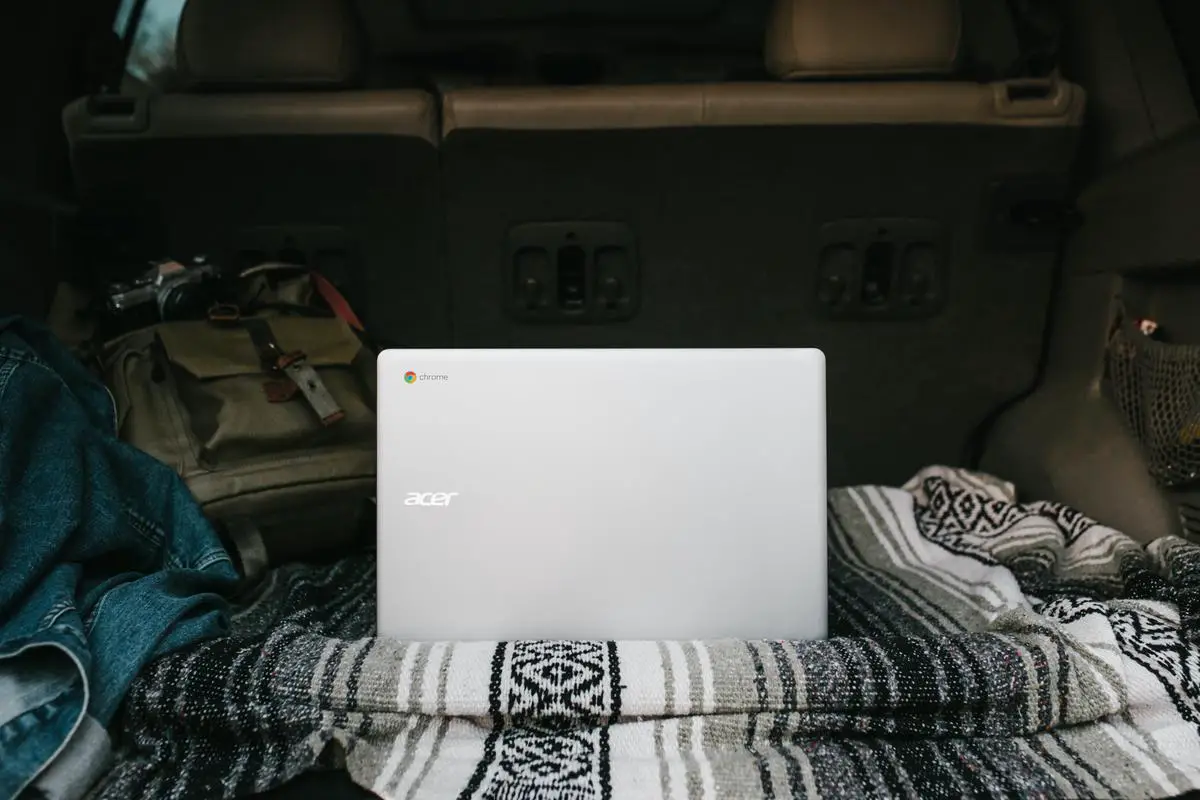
94,468,1200,800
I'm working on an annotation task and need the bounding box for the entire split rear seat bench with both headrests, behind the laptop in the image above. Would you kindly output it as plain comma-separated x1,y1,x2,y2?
65,0,1084,485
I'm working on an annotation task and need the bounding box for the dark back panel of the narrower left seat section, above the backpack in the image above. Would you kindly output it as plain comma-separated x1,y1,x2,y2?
63,116,449,345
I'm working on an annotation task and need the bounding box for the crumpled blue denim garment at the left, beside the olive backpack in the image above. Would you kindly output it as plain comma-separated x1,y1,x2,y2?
0,318,238,798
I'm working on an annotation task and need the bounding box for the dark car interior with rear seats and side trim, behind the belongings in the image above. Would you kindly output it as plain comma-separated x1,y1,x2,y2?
7,0,1200,798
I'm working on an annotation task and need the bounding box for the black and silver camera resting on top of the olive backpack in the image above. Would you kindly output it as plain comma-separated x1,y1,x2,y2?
107,258,223,327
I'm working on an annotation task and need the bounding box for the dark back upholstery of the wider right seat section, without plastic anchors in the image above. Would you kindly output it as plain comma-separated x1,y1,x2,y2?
443,116,1075,486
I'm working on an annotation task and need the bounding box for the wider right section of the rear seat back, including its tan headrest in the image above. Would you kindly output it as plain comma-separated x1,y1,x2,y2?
442,0,1084,483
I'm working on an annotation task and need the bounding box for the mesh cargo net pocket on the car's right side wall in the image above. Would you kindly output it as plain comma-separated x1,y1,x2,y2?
1108,326,1200,489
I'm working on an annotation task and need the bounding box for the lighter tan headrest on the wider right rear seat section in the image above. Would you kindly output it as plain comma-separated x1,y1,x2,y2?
764,0,962,80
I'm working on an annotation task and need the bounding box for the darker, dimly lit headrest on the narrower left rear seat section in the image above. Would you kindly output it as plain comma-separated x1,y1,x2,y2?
175,0,364,91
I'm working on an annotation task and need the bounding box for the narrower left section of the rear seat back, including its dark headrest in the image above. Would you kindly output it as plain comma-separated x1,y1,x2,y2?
64,0,449,345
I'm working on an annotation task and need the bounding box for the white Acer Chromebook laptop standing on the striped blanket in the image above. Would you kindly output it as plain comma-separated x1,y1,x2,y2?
378,349,828,642
